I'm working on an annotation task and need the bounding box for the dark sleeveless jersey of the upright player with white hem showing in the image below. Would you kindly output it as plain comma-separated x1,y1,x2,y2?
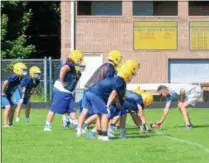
58,61,77,92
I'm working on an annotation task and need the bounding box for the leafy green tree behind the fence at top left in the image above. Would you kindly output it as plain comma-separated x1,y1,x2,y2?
1,1,35,58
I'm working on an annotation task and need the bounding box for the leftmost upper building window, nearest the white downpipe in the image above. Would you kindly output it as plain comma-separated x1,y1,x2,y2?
77,1,122,16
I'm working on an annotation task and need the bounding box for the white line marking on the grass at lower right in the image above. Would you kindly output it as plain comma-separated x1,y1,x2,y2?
126,121,209,153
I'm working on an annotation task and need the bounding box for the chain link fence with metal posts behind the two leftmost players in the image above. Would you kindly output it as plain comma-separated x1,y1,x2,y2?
1,57,61,102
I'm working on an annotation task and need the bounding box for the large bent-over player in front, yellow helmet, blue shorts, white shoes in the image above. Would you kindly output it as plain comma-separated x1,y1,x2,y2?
77,66,132,141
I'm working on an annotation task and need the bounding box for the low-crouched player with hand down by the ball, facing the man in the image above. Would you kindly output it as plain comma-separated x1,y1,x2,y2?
117,89,153,138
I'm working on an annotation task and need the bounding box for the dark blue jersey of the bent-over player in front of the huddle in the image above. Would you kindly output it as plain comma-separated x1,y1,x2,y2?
89,76,126,104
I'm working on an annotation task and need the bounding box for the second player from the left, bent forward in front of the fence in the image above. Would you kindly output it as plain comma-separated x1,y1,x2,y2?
14,66,41,123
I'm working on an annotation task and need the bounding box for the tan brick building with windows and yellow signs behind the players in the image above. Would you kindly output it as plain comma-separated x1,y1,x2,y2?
61,0,209,88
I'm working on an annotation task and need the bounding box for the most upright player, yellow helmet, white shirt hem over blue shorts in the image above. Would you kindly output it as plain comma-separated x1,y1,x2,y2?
44,50,84,131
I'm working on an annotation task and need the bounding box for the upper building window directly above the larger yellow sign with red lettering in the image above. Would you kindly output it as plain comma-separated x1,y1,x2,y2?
133,1,178,16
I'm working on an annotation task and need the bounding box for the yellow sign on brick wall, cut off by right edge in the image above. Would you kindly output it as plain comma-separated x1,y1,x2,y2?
189,22,209,50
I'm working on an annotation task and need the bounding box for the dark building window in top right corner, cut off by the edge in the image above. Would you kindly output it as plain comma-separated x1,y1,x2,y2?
189,1,209,16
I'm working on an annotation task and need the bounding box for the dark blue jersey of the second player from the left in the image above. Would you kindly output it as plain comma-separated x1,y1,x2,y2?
20,75,40,97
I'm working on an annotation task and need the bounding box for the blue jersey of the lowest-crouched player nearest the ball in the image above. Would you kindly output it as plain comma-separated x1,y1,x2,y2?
122,91,144,111
